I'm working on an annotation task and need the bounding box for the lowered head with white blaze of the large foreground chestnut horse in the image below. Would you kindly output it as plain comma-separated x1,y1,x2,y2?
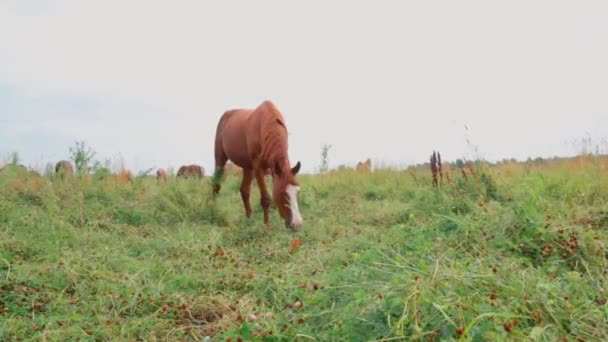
271,161,302,229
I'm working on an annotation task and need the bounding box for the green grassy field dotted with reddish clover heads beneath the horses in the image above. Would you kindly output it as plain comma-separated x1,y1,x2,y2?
0,156,608,341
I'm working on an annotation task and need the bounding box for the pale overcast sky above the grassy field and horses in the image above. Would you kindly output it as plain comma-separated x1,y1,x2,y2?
0,0,608,172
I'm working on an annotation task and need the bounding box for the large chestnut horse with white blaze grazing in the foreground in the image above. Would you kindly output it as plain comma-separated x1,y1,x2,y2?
213,101,302,229
